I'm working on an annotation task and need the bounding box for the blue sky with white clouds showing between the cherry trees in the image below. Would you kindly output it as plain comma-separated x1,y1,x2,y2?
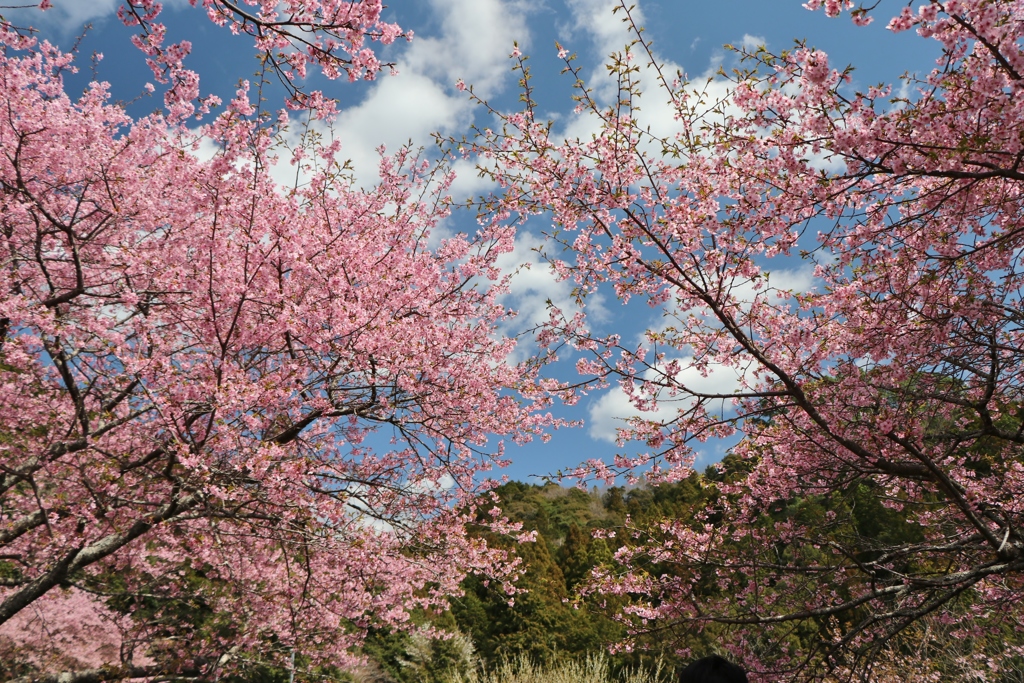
9,0,937,479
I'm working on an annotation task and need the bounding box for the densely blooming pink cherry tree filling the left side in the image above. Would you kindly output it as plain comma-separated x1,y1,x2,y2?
0,7,554,681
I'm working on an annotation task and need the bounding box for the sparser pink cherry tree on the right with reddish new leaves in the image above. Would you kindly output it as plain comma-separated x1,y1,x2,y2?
475,0,1024,680
